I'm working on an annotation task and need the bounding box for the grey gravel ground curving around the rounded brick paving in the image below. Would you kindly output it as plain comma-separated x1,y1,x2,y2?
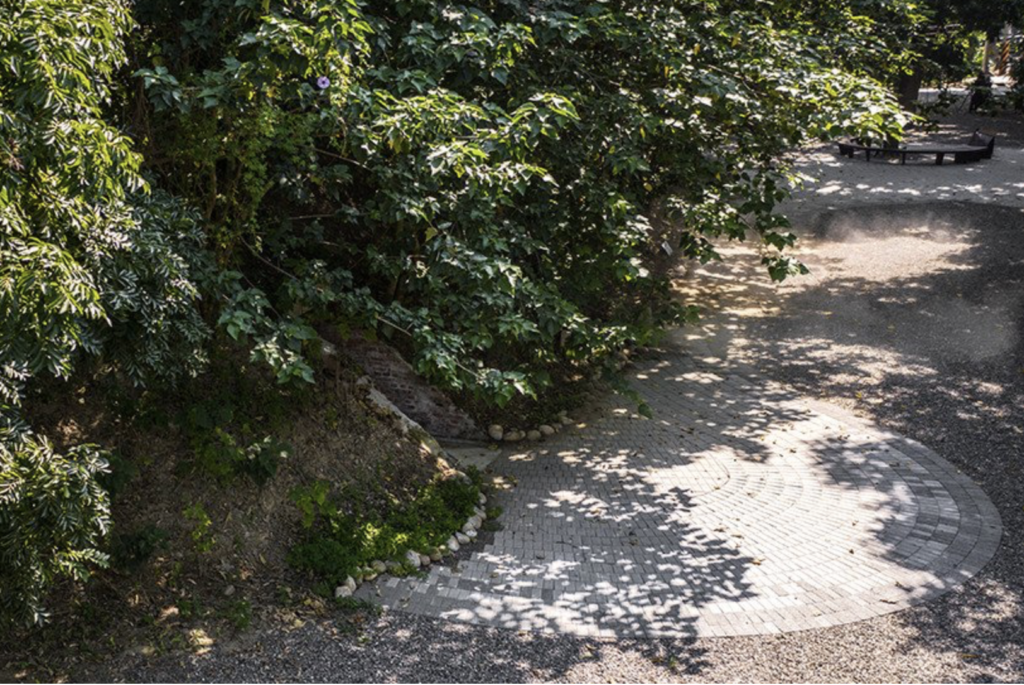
89,122,1024,682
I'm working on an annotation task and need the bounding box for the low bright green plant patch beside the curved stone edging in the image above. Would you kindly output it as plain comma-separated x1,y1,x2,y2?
288,476,480,587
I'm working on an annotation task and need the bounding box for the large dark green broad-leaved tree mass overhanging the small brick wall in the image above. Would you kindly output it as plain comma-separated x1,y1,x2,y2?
131,0,902,404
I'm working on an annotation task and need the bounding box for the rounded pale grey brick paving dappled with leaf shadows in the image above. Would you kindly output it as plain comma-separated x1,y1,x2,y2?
360,356,1000,637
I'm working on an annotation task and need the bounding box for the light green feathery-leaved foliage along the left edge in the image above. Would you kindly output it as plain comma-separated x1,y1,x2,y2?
0,0,210,623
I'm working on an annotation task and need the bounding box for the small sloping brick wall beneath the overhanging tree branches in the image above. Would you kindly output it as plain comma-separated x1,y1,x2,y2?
328,335,486,440
